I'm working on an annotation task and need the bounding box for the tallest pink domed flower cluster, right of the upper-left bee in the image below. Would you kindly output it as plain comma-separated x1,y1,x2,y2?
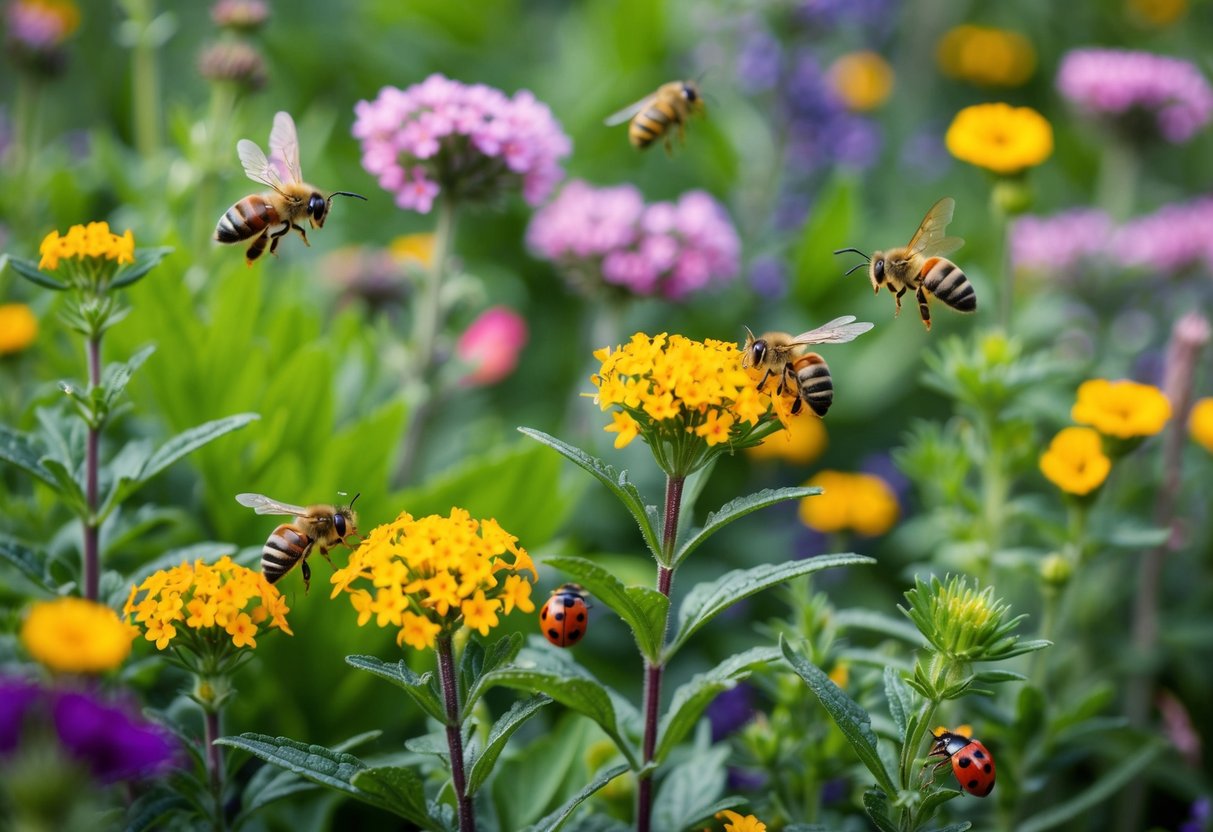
353,74,573,213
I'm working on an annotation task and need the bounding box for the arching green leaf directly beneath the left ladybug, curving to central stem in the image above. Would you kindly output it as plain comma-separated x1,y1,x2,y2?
483,648,640,769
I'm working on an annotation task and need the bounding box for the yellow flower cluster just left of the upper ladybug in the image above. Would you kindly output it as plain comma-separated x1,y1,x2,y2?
332,508,539,650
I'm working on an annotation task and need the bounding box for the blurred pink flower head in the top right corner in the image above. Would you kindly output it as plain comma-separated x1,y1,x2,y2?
1057,49,1213,144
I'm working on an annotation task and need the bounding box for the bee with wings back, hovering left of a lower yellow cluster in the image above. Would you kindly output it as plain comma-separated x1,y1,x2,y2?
235,494,359,592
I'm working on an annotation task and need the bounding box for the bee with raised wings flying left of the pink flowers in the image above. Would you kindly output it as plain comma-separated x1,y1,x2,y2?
215,113,366,266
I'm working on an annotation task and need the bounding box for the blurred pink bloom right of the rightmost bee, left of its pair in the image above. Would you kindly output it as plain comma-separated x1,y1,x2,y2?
1010,209,1112,275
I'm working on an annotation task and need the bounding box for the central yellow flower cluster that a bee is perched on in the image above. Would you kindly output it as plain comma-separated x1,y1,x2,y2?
591,332,770,448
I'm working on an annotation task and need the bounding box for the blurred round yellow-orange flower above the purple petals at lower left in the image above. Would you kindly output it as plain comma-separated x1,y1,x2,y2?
21,598,137,673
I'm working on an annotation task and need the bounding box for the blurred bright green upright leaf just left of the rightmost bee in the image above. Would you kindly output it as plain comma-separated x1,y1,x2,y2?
792,173,856,307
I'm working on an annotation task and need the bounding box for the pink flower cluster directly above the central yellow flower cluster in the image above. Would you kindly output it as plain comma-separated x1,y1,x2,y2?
526,179,741,300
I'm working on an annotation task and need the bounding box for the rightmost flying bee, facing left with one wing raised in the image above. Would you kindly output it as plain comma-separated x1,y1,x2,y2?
835,196,978,330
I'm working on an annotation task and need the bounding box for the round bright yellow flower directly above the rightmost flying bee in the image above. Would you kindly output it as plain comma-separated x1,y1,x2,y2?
945,103,1053,173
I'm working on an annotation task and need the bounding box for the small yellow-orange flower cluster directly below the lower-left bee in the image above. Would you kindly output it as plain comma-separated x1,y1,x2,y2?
123,555,294,650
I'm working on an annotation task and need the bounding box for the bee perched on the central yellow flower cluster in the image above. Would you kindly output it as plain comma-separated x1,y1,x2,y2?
741,315,872,416
